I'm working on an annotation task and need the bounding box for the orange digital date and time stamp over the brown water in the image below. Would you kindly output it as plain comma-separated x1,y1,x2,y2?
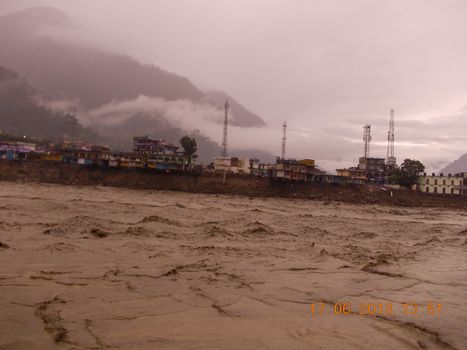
310,302,442,317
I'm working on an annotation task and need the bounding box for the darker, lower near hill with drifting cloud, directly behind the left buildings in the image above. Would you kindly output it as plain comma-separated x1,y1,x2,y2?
0,66,273,164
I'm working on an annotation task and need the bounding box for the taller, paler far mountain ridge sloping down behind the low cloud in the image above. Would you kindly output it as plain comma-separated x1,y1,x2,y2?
0,7,266,127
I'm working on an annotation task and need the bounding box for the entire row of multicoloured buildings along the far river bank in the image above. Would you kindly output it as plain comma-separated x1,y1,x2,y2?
0,136,467,194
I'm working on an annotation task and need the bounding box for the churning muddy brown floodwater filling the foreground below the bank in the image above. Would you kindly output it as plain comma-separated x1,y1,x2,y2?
0,182,467,350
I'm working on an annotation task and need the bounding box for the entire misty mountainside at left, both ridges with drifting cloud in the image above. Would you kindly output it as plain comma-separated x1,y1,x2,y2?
0,7,273,163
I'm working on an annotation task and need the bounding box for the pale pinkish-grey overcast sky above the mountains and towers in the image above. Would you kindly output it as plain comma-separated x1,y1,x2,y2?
0,0,467,171
